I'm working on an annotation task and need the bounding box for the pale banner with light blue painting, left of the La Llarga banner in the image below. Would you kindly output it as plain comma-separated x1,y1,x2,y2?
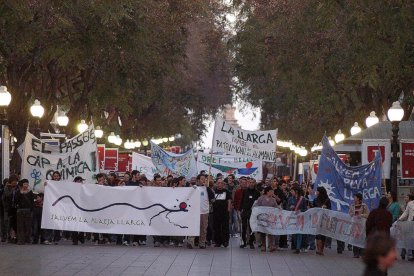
151,142,197,179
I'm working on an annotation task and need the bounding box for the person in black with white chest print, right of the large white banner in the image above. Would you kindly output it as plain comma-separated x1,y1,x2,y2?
213,179,232,247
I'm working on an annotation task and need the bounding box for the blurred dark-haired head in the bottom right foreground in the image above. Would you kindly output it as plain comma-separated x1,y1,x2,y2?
363,233,397,276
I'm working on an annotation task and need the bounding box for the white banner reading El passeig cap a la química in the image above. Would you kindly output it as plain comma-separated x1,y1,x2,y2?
22,125,98,192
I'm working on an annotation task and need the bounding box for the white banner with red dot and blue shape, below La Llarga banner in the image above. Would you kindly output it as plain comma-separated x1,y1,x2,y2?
197,152,263,181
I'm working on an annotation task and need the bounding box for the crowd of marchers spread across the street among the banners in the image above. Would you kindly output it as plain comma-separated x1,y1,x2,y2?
0,170,414,274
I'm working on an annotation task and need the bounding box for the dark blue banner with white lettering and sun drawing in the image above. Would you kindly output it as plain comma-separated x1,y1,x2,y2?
315,136,381,213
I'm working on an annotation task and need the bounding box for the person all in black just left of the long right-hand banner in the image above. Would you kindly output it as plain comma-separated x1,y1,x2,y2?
240,181,260,249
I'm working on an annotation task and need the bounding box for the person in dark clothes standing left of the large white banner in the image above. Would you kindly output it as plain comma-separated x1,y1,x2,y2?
16,179,34,244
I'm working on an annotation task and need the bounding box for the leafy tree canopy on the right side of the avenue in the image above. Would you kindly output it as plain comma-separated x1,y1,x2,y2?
232,0,414,146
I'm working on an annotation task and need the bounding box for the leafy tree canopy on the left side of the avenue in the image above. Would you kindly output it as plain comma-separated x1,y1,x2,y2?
0,0,231,147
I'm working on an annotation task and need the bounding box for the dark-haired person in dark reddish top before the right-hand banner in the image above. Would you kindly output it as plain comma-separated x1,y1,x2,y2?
365,197,392,237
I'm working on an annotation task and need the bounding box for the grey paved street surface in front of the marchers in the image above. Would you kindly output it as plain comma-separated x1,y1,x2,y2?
0,239,414,276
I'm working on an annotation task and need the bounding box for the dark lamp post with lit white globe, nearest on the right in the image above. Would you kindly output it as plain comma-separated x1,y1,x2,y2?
388,101,404,193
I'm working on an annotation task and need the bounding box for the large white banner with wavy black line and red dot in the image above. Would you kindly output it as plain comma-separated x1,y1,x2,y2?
42,181,200,236
